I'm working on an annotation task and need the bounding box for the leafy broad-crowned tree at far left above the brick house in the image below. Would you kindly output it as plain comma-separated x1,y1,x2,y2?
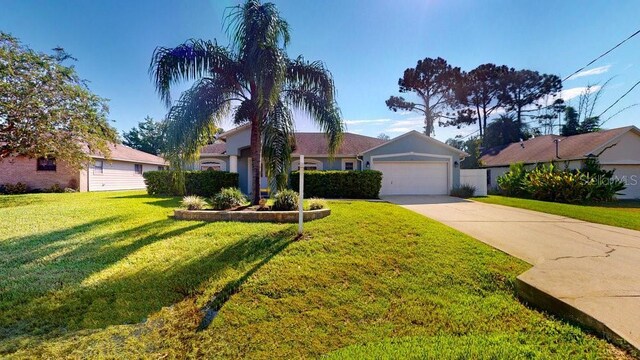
0,32,118,168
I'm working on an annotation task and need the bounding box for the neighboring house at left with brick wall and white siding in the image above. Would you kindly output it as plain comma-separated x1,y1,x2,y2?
0,144,166,191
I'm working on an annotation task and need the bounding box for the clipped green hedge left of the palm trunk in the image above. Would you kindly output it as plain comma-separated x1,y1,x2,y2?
143,170,239,197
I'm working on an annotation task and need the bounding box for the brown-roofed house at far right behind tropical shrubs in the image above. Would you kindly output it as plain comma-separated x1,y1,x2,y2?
480,126,640,199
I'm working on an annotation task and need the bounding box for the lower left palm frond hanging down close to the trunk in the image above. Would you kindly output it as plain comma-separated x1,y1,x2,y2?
165,78,234,160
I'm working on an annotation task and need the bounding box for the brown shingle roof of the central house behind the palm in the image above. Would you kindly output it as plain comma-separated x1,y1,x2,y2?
200,130,387,156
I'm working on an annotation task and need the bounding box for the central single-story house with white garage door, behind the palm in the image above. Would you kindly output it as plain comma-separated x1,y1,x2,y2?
195,126,468,195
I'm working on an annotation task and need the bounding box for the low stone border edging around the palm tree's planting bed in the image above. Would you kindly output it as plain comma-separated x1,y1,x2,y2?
173,209,331,223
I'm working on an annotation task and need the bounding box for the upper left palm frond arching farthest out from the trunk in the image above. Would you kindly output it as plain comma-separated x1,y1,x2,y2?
149,39,239,107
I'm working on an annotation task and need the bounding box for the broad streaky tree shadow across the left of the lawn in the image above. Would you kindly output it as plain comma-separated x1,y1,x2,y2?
0,218,296,344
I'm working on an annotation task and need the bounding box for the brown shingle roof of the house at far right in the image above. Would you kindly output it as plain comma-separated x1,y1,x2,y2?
480,126,640,167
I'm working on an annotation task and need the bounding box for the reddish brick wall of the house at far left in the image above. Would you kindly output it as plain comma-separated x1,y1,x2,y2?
0,156,80,193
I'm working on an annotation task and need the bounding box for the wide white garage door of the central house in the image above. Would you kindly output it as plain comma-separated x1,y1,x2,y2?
373,161,449,195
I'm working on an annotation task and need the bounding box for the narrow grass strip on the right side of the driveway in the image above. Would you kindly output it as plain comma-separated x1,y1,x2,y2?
473,195,640,230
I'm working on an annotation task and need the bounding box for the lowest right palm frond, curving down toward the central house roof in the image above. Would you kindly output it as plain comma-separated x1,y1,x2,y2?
284,89,344,156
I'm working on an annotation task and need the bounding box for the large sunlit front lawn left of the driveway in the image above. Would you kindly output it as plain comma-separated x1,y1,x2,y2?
0,192,620,359
